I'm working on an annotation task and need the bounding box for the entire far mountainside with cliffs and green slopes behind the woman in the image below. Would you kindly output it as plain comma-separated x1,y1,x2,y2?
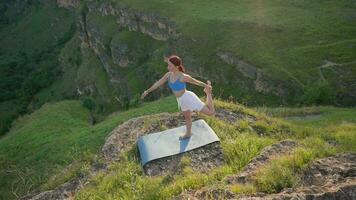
0,0,356,136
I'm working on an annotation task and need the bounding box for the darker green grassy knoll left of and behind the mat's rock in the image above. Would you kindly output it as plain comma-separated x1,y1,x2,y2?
0,96,177,199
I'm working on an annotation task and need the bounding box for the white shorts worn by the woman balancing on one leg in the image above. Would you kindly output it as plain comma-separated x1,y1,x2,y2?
177,90,205,111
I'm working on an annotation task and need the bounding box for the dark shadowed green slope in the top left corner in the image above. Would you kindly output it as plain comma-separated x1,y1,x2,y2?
0,1,76,135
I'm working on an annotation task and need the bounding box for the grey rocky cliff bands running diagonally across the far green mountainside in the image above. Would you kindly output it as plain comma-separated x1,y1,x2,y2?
63,0,302,104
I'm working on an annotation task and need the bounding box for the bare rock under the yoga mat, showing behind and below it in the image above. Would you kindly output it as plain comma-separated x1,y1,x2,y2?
102,113,224,176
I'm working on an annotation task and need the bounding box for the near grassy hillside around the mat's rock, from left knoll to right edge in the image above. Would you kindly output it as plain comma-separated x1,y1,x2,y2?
0,96,356,199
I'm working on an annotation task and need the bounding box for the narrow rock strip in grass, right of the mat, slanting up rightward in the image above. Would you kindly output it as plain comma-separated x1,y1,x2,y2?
225,140,298,183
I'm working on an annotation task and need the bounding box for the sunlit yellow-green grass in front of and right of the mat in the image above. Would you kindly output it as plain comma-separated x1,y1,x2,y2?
76,100,356,199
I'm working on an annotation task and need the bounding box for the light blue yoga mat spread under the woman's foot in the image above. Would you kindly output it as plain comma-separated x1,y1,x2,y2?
137,119,220,166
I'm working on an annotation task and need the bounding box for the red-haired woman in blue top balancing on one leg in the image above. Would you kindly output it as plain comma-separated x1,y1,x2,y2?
141,55,215,139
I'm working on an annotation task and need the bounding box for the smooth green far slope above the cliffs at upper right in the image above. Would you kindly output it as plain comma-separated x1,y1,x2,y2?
108,0,356,104
